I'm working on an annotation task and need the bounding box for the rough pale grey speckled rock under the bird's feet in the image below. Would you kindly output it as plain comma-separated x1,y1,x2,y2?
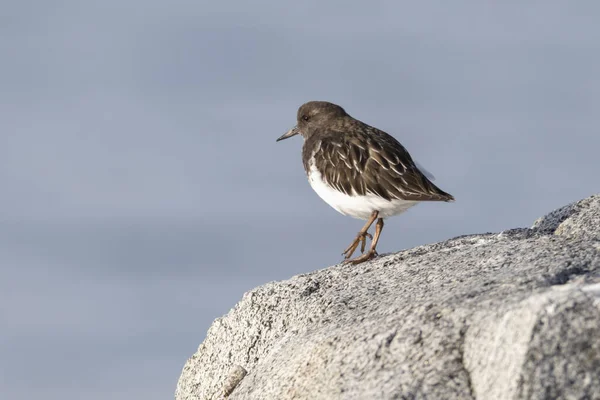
175,195,600,400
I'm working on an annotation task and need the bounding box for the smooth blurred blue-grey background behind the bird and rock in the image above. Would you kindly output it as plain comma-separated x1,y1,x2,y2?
0,0,600,400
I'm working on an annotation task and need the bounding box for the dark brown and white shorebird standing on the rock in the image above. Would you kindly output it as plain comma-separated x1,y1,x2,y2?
276,101,454,264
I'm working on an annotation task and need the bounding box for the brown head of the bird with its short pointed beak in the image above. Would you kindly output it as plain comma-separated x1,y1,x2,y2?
277,101,348,142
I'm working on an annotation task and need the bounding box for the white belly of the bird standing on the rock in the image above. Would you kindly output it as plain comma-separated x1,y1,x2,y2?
308,165,418,220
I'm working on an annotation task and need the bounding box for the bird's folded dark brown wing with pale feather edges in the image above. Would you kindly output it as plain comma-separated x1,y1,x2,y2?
313,128,454,201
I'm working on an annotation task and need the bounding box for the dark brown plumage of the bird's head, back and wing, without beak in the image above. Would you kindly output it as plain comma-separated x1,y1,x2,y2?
298,102,454,201
